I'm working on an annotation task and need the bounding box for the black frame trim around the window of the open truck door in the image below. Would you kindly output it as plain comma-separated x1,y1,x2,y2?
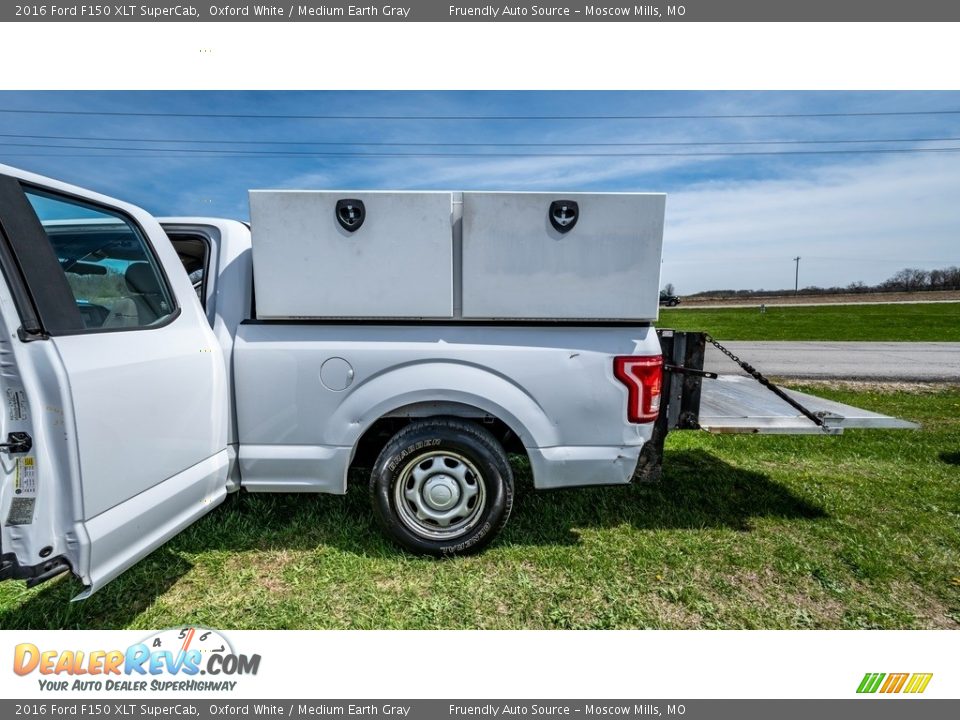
7,176,183,338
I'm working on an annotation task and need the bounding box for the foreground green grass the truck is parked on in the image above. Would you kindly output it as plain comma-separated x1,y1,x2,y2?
0,389,960,629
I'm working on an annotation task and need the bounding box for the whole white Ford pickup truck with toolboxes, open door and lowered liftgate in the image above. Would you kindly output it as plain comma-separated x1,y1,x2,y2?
0,166,909,597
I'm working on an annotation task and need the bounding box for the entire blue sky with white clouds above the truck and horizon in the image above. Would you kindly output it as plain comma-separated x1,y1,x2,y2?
0,91,960,293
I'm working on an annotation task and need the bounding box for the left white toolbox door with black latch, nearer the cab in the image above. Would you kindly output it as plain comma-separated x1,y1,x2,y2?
250,190,453,319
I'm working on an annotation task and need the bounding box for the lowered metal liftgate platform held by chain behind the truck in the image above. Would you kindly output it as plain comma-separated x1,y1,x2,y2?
699,375,919,435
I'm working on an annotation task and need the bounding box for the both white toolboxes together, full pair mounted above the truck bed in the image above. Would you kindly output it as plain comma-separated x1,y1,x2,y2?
250,190,665,321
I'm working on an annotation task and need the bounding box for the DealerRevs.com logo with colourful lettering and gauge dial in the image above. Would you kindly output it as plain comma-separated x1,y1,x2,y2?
13,627,260,692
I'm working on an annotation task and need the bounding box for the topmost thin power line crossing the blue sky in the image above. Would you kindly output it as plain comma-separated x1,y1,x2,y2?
0,108,960,121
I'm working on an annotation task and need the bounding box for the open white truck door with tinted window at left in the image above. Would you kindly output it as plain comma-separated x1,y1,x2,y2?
0,166,228,597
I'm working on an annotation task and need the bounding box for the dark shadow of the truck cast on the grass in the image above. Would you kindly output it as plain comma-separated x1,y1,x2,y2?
0,450,826,629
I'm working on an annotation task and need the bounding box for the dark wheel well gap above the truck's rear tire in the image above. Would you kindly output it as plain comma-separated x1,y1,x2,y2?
350,403,527,469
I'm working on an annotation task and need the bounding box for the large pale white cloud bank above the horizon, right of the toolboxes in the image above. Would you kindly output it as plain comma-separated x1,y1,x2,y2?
662,153,960,293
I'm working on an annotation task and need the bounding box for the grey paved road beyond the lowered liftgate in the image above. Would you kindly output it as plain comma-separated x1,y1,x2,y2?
705,341,960,382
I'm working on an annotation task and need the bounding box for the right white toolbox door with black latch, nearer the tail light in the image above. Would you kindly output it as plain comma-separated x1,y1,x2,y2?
463,192,666,320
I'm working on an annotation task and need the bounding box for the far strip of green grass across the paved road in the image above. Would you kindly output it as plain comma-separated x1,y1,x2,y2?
657,303,960,342
